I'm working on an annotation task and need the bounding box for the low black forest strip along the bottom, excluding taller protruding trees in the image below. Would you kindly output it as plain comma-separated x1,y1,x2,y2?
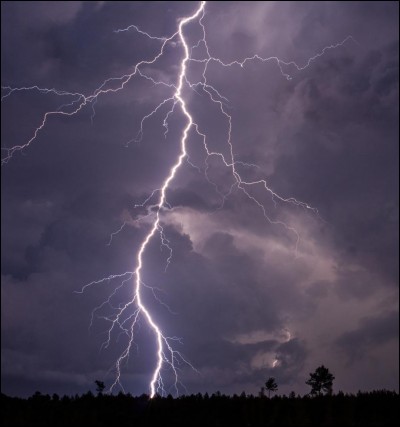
1,390,399,427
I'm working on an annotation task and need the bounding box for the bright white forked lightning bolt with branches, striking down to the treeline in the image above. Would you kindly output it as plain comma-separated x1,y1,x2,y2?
1,1,354,397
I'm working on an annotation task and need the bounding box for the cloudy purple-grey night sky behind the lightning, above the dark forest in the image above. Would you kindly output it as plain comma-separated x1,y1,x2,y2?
1,1,399,396
